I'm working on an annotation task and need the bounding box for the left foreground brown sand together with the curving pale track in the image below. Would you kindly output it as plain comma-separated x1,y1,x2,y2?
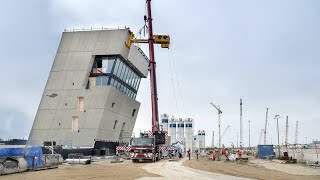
0,159,250,180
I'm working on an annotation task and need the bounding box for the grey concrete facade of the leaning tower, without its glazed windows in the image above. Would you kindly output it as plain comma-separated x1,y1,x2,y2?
28,29,149,147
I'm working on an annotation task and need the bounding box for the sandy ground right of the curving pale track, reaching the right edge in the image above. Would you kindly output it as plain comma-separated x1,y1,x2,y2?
183,157,320,180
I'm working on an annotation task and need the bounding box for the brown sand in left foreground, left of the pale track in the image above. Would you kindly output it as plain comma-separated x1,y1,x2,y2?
0,160,158,180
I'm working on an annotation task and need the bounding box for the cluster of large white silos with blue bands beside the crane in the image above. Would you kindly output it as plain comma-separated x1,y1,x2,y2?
160,114,194,152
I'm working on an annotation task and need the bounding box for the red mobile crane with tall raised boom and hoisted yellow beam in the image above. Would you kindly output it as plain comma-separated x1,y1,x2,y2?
127,0,170,162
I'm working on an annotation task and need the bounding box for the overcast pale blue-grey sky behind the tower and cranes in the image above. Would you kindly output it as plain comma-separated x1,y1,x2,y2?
0,0,320,146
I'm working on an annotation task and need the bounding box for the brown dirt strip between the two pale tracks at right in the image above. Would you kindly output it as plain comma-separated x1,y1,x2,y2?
183,158,320,180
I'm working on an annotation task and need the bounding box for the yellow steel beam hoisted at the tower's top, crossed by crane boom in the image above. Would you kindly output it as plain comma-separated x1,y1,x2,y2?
127,31,170,49
